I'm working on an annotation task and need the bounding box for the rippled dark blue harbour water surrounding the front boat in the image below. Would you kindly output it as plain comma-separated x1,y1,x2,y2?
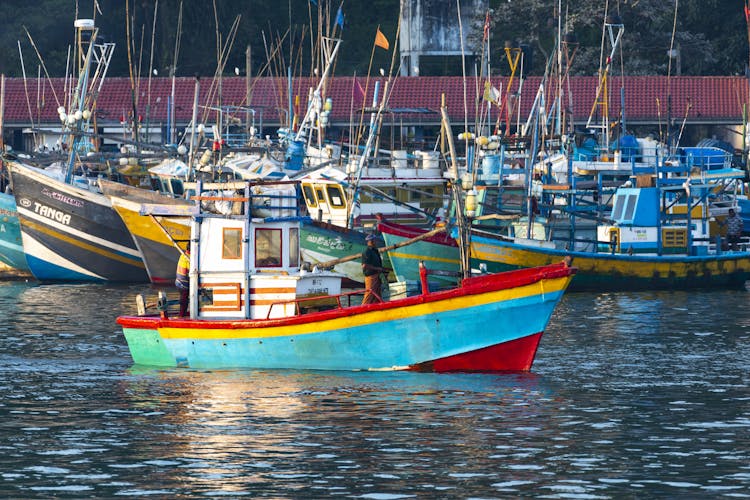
0,282,750,500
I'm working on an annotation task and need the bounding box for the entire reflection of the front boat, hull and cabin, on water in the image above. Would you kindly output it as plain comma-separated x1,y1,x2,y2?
119,366,555,488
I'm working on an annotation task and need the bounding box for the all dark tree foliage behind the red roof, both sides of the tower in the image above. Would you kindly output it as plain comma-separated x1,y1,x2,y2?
0,0,748,77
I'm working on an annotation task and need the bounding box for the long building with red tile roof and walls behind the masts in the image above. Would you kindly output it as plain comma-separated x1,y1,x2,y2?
4,76,748,147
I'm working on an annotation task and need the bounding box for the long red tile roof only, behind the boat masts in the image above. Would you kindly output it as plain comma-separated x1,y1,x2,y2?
0,76,748,125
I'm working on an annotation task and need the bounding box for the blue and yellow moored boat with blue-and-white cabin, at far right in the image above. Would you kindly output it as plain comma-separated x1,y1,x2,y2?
471,167,750,291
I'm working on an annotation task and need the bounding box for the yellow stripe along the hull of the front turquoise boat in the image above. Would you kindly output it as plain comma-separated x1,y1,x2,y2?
159,276,572,339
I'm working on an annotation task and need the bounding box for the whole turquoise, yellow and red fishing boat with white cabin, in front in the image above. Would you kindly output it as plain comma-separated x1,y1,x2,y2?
117,180,575,372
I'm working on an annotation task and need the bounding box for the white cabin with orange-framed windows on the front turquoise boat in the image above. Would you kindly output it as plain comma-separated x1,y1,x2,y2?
190,185,342,319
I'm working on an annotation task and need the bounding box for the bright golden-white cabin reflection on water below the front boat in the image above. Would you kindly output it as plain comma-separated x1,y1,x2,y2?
118,365,316,495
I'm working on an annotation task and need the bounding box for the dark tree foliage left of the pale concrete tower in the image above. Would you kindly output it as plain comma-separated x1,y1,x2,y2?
0,0,399,77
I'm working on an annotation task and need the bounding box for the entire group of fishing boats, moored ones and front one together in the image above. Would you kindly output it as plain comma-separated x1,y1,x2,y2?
0,12,750,371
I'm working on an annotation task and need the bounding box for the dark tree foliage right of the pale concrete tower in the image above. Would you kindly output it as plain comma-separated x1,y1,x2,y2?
490,0,748,75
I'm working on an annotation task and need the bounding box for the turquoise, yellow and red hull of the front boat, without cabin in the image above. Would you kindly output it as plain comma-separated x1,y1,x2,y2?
117,264,575,371
